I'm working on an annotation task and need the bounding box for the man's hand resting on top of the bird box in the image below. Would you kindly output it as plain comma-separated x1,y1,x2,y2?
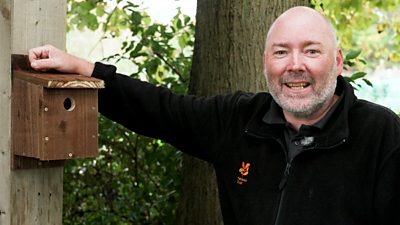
29,45,94,76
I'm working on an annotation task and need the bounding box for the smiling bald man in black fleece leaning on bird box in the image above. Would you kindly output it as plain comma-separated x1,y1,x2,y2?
29,7,400,225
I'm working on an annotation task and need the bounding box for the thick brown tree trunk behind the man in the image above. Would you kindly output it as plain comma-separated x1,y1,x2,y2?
177,0,309,225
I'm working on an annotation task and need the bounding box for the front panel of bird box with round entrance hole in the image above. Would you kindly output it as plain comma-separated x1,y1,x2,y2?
40,88,98,160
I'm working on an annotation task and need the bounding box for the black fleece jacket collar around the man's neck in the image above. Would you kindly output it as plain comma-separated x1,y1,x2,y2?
246,76,357,148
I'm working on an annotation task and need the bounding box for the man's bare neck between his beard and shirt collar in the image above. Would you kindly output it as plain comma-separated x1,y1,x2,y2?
283,95,339,131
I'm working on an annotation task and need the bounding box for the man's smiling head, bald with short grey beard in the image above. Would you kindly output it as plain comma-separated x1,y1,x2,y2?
264,7,343,118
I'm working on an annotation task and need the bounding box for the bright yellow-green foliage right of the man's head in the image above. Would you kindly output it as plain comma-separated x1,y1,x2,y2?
311,0,400,70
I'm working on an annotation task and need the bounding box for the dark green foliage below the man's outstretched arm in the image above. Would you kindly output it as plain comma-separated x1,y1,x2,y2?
63,117,181,224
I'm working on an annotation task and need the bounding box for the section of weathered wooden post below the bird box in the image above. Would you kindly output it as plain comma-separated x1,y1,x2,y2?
10,167,63,225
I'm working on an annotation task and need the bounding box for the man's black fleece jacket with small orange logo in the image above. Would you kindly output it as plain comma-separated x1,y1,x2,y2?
93,63,400,225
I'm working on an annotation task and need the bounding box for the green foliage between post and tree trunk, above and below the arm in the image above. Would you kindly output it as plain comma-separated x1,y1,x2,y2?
63,0,194,224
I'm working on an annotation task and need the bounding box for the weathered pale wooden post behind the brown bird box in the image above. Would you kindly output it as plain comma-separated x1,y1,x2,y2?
5,0,66,225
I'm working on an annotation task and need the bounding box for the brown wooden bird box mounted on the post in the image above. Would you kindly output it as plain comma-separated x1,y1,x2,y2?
12,56,104,169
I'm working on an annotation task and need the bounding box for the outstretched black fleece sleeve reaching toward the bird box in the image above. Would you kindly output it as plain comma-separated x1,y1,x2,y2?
92,62,245,162
